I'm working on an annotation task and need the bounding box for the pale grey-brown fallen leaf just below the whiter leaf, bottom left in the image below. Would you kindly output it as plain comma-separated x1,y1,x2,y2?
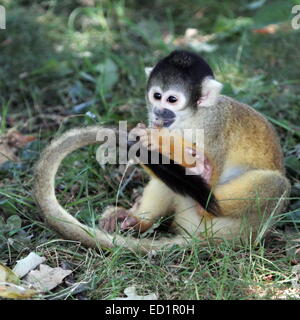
25,264,72,292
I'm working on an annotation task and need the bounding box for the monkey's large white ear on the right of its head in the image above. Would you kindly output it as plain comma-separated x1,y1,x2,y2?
197,78,223,107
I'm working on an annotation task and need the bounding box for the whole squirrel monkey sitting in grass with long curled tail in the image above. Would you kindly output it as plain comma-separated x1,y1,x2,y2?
34,50,290,251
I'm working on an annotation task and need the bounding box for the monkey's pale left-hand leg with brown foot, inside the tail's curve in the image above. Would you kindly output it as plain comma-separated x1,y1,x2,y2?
100,178,174,232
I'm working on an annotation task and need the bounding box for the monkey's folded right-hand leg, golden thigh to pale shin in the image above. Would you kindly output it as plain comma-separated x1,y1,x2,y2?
172,170,290,239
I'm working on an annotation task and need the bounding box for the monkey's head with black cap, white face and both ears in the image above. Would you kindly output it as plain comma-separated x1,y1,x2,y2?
145,50,222,127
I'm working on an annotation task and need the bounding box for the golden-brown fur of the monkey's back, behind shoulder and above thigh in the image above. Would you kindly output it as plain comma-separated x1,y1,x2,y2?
219,96,285,173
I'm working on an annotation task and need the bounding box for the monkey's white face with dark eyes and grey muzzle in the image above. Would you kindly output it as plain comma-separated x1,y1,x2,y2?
146,85,192,127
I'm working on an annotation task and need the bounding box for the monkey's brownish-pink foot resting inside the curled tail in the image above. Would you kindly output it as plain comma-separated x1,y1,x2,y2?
99,207,139,232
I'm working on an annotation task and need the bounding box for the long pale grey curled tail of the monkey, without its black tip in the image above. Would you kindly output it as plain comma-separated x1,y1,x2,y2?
34,126,188,252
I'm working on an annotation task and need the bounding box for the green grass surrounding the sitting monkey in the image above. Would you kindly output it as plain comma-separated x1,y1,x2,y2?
0,0,300,299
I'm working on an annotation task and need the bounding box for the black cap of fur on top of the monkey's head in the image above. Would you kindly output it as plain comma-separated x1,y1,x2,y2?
148,50,214,106
